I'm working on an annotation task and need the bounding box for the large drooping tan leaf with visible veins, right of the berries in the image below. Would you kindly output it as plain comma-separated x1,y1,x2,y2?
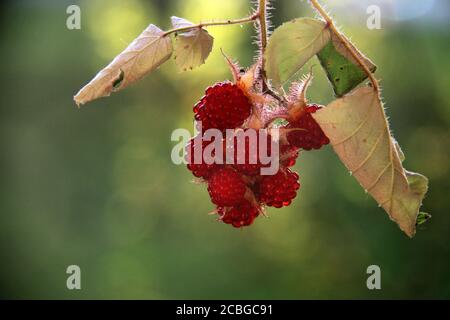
313,87,428,237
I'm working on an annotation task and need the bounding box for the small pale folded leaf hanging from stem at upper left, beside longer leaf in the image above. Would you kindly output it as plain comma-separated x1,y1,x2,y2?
171,17,214,71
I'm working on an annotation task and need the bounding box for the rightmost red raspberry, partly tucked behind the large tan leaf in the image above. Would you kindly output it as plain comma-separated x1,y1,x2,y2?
286,105,330,150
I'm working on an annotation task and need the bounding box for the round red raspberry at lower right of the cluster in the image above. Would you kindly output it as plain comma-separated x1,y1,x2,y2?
259,169,300,208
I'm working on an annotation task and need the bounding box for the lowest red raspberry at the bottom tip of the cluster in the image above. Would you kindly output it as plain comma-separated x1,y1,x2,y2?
217,200,259,228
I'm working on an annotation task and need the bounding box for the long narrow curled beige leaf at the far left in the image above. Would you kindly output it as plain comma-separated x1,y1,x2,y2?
74,24,173,106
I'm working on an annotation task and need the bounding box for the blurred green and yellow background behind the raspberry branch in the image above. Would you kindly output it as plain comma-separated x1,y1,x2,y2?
0,0,450,299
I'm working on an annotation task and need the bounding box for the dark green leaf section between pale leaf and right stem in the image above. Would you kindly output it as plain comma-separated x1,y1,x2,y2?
317,34,376,97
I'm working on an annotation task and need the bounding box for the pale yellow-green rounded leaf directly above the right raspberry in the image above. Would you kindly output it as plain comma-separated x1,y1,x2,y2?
265,18,331,88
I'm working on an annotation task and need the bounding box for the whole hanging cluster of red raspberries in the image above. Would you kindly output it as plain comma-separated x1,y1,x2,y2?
186,82,329,228
